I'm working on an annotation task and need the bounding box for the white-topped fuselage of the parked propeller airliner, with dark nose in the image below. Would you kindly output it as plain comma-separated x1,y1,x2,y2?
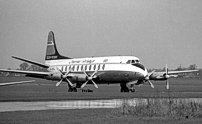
45,56,148,83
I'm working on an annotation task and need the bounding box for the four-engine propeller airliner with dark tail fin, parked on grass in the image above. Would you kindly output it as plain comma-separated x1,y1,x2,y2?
0,31,198,92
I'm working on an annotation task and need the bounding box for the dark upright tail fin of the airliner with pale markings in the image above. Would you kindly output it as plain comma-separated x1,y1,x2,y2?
45,31,71,60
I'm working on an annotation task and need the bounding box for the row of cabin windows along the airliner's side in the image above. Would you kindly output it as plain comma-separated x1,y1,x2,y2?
62,64,105,71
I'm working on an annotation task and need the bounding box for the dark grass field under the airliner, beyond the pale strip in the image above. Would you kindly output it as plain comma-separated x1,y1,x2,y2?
0,77,202,102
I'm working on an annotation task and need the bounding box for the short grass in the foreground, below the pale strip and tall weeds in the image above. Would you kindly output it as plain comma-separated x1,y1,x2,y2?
0,109,202,124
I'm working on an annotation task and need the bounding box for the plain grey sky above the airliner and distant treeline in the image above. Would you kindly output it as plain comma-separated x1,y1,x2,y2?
0,0,202,69
